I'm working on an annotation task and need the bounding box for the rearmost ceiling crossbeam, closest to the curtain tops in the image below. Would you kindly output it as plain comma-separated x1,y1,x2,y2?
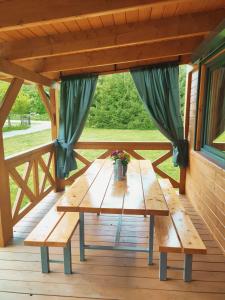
18,37,202,73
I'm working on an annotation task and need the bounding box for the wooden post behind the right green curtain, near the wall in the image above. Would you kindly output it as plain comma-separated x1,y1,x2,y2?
179,71,192,194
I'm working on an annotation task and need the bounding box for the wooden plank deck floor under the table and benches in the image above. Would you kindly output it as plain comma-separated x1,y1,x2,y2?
0,194,225,300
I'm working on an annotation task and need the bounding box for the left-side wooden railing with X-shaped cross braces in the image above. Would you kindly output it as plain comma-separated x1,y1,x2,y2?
6,143,55,225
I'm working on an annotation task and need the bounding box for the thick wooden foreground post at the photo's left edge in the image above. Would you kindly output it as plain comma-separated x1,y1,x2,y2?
0,128,13,247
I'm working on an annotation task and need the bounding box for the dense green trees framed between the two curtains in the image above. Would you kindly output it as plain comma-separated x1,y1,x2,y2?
87,73,154,129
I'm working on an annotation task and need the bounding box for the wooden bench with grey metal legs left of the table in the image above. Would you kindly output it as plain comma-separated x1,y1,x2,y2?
24,205,79,274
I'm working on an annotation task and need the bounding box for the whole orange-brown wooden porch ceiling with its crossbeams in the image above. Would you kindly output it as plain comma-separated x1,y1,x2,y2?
0,0,225,85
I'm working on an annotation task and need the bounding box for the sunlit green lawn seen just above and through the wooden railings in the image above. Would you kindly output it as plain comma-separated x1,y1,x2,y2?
4,128,179,207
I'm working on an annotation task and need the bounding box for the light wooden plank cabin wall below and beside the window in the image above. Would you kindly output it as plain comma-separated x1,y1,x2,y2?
186,71,225,252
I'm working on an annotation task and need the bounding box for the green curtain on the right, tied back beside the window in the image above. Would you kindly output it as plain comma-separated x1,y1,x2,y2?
131,64,188,167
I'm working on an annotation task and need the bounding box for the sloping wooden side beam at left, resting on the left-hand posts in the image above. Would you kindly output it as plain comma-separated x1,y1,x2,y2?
0,58,53,86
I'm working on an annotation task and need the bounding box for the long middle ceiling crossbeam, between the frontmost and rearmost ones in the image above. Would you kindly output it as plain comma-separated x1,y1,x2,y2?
0,9,225,60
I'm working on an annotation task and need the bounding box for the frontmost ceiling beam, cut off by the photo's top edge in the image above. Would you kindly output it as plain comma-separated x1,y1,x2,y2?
0,0,187,31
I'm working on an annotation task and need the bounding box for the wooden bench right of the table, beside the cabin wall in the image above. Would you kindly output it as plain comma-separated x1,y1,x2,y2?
155,179,207,282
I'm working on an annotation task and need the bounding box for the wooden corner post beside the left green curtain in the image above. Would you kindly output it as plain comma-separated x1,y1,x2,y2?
50,88,65,192
